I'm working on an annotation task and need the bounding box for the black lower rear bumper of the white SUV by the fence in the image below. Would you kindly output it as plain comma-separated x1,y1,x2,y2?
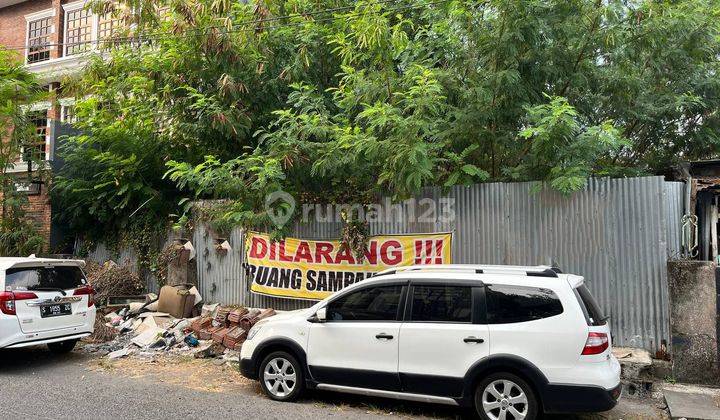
542,383,622,413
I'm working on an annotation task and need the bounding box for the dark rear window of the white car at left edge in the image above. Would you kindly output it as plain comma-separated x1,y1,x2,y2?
5,266,85,291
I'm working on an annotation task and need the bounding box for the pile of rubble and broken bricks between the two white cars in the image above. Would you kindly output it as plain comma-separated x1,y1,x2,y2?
85,286,275,361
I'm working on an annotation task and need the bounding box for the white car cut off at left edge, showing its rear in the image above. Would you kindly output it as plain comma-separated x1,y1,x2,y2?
0,256,96,353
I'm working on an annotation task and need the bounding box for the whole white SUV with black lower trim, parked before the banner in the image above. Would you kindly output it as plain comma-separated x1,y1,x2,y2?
240,265,621,420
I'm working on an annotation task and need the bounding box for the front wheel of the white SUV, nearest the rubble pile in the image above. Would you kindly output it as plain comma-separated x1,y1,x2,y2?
258,351,305,401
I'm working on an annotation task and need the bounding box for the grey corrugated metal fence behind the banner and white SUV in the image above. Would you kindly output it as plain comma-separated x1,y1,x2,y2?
81,177,684,350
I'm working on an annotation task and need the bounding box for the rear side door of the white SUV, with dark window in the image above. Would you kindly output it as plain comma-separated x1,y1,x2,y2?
399,282,489,397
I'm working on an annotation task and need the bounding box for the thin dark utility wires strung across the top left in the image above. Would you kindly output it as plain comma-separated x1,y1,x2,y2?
2,0,451,50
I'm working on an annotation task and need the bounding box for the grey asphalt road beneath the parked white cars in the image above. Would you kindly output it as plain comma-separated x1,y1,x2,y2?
0,347,664,420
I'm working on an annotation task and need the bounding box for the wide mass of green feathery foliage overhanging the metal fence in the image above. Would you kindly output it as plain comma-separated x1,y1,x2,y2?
55,0,720,236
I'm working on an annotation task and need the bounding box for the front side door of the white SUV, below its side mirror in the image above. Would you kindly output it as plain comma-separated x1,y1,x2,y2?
307,284,407,391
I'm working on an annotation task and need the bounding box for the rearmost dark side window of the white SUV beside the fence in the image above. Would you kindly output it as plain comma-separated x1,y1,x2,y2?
486,285,563,324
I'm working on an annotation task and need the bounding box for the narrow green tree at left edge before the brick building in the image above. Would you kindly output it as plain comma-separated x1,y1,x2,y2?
0,49,46,256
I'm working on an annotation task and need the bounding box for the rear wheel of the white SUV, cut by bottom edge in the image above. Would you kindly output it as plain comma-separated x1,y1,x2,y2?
474,372,539,420
